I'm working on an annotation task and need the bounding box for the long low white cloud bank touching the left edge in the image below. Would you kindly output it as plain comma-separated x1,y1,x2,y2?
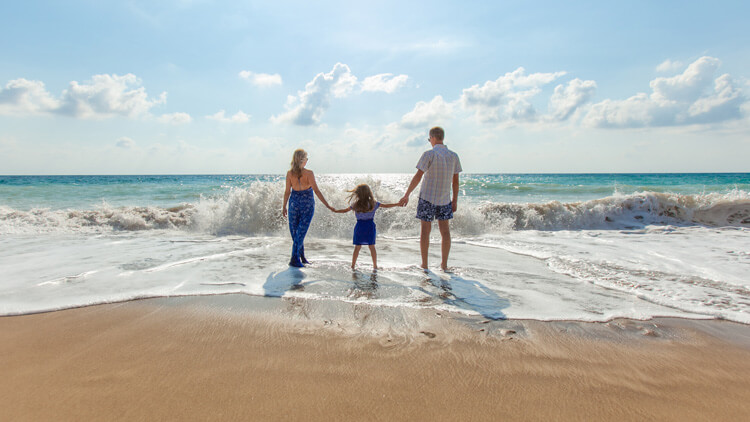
0,73,166,119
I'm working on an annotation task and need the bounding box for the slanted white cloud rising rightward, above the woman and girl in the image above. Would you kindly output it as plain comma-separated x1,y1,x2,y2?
271,63,357,126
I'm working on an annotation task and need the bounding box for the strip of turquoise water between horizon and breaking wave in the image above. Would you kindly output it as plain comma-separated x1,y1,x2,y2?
0,173,750,211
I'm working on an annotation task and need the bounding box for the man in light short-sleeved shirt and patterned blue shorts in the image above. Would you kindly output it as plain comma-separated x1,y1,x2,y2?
399,127,461,271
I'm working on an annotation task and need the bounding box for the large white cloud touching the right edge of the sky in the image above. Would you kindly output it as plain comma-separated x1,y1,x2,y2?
583,57,746,127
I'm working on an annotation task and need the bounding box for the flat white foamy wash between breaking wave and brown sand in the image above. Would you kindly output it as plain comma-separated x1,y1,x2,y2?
0,229,750,323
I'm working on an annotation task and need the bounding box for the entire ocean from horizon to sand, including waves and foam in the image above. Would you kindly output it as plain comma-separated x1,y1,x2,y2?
0,173,750,324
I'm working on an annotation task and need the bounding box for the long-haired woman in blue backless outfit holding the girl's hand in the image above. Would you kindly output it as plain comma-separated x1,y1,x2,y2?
281,149,331,267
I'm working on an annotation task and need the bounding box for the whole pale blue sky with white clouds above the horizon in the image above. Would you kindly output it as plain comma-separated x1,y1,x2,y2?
0,0,750,175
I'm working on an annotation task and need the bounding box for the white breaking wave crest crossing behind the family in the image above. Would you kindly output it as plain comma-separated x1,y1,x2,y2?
0,181,750,237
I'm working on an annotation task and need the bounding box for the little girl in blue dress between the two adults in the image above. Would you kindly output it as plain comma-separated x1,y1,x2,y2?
333,184,398,270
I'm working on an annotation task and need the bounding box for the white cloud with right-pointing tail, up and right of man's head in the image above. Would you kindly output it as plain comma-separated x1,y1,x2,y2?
460,67,565,122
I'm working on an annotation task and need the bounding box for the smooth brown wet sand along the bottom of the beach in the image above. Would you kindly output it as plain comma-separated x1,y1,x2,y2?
0,295,750,421
